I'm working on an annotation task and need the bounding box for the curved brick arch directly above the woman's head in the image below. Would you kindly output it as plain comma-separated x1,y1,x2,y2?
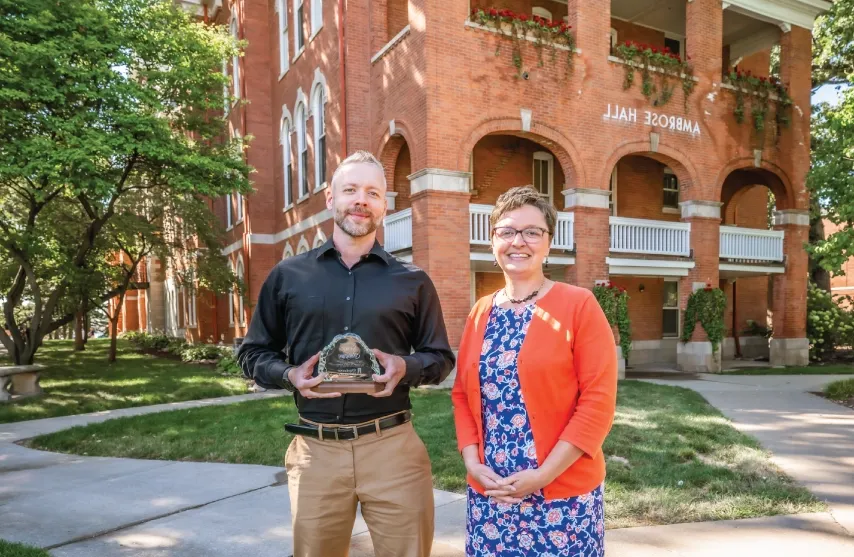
457,118,587,189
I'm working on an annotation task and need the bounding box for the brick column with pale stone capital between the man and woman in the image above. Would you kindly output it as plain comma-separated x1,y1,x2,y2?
409,168,471,350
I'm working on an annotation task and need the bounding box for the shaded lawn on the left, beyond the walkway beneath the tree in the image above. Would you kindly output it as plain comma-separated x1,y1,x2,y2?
0,339,247,423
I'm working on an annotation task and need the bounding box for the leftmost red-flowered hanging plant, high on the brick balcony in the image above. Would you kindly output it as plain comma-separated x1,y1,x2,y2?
469,8,575,77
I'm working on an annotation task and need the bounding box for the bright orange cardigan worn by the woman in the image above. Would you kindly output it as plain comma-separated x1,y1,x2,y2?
451,282,617,499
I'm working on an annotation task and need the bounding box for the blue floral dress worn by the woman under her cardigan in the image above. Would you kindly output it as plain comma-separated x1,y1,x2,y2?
466,303,605,557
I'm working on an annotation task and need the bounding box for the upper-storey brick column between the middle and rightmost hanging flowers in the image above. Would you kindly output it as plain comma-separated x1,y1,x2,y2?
685,0,724,83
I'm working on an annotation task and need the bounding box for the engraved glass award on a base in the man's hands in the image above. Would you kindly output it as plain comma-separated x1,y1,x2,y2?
312,333,385,393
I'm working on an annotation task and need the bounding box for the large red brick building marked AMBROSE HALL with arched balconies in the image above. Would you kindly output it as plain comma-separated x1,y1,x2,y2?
118,0,830,370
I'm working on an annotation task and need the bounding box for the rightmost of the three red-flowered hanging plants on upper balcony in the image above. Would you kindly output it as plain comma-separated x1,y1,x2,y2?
724,68,792,132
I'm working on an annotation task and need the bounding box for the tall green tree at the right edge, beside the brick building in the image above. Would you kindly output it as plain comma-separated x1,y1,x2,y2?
807,0,854,291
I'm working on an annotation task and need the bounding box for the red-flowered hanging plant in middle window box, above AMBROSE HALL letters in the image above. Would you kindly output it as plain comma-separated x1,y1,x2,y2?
614,41,695,110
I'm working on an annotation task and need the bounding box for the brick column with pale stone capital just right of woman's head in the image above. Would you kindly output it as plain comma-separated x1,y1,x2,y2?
563,188,611,289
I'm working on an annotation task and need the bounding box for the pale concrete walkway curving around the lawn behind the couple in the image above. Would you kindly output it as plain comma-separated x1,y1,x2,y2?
0,375,854,557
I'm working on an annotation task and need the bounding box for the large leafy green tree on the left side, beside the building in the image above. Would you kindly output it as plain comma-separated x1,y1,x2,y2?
0,0,250,364
